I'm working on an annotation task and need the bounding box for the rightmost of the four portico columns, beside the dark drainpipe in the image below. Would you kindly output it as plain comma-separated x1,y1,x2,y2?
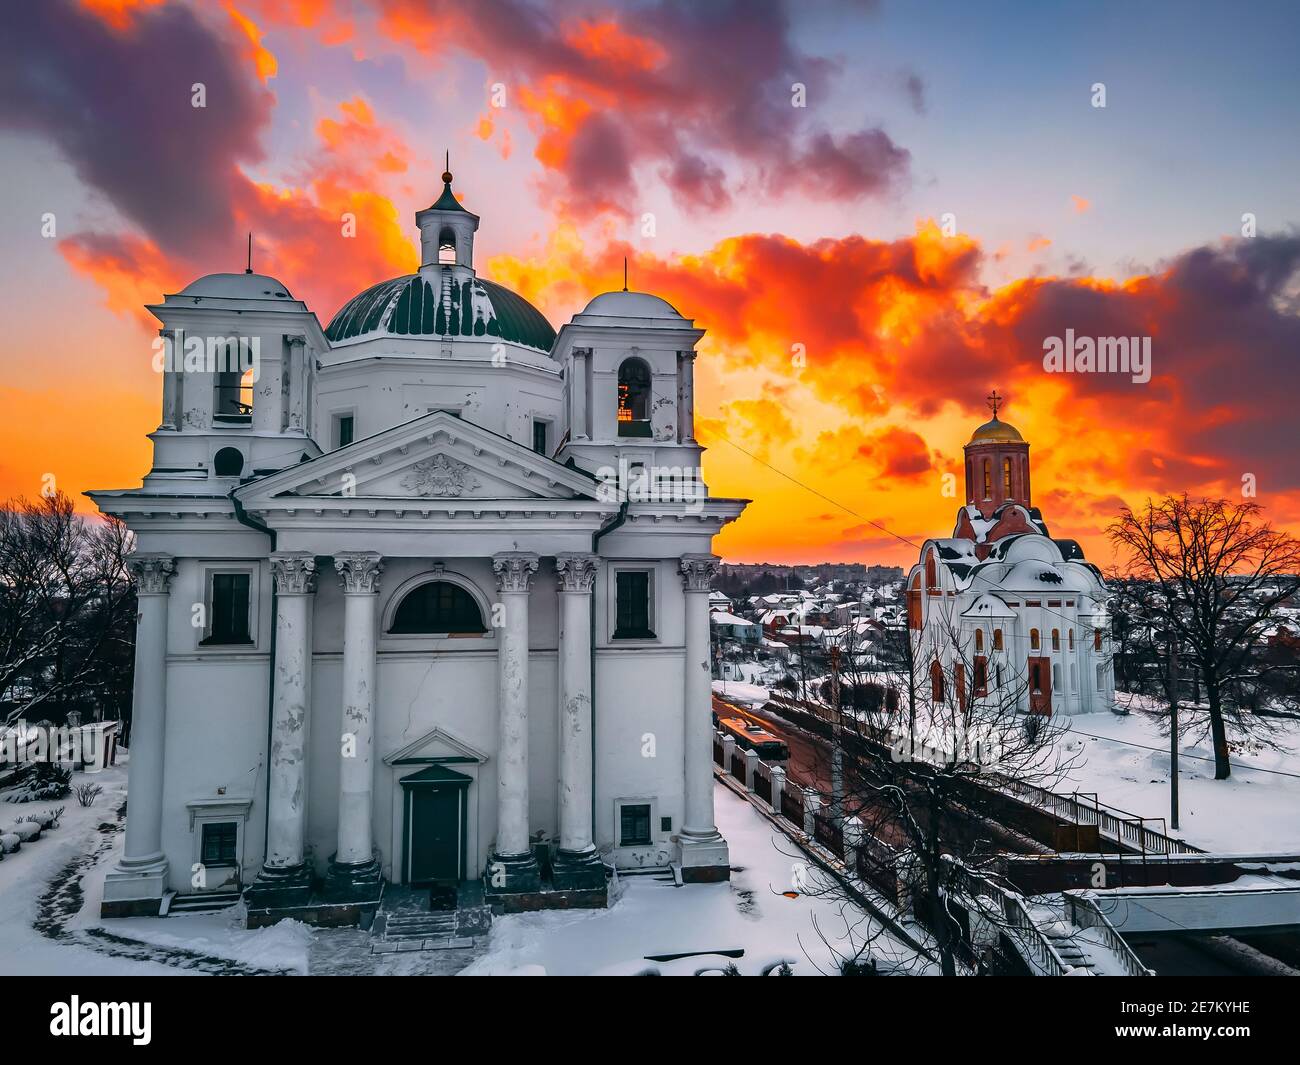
555,554,605,868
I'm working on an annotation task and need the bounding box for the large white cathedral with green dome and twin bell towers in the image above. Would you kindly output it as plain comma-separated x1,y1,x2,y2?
90,173,746,923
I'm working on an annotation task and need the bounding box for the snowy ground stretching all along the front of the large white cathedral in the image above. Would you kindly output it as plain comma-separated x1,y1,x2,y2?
0,766,913,975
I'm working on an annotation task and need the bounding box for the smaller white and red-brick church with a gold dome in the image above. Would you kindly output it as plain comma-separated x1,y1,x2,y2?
906,391,1115,715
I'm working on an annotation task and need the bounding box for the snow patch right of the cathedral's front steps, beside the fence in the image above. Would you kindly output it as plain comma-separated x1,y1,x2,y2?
463,784,913,975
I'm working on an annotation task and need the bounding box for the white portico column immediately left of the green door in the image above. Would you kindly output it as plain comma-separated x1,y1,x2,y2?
334,551,384,866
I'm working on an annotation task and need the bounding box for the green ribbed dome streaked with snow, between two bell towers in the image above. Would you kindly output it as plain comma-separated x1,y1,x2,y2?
325,273,555,354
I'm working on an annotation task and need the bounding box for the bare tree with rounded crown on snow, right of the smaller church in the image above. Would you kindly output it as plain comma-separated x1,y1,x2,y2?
1108,494,1300,780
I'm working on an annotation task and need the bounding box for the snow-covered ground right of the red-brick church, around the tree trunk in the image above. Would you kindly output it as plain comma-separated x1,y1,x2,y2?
1054,711,1300,854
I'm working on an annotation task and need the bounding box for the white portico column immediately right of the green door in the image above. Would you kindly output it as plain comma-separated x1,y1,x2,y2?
489,551,537,891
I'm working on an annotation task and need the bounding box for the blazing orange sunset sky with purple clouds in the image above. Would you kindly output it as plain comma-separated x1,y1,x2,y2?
0,0,1300,566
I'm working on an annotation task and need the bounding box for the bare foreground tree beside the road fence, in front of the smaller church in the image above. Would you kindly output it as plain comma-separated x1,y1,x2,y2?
790,600,1075,975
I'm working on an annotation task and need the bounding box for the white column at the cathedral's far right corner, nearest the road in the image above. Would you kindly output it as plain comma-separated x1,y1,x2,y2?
680,554,731,880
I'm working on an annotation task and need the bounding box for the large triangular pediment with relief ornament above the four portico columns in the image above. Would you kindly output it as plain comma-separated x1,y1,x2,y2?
238,411,597,507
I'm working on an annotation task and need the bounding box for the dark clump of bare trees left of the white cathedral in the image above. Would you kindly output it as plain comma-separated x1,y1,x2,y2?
0,493,135,722
